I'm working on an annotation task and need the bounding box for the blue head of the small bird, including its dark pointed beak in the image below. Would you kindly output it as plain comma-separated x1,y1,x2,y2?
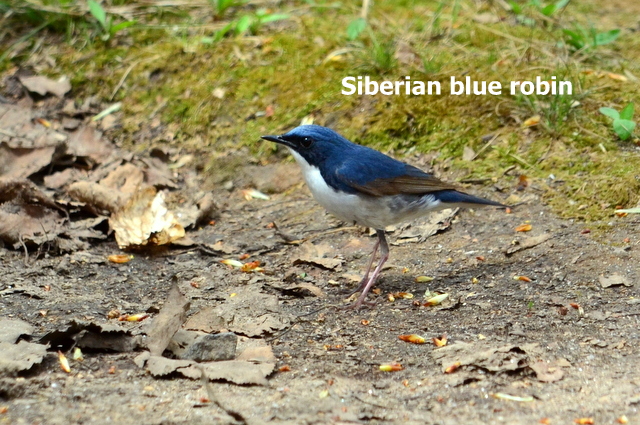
262,125,353,166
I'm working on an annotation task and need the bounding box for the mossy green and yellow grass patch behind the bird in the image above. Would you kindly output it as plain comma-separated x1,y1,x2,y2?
0,0,640,220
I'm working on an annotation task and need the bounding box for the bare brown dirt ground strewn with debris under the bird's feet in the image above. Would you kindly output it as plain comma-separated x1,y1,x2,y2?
0,153,640,424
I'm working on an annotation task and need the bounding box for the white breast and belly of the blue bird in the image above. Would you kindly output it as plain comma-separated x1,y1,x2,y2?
289,149,442,229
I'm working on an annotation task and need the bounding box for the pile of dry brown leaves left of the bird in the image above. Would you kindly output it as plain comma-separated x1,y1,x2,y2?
0,76,215,252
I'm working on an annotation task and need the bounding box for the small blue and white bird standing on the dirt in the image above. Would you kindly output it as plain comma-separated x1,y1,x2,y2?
261,125,506,309
